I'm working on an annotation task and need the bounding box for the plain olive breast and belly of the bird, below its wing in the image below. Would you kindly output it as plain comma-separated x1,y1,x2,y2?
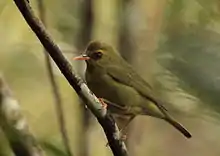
86,69,141,109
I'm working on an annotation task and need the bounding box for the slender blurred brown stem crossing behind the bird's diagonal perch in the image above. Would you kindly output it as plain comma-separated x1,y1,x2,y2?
38,0,73,156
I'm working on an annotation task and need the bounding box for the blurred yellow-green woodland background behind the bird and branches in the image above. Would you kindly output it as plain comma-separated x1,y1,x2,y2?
0,0,220,156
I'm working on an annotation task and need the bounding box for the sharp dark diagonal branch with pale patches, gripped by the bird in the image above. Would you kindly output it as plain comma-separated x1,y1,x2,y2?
14,0,128,156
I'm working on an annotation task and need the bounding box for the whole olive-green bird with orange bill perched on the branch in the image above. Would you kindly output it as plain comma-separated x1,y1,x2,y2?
74,41,191,138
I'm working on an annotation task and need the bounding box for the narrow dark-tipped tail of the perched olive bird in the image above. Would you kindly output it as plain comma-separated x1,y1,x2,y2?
165,117,192,138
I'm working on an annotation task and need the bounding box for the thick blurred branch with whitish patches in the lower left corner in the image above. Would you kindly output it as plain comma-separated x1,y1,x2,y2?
0,76,44,156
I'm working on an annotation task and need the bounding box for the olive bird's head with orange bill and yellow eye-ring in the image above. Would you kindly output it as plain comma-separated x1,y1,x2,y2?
74,41,118,67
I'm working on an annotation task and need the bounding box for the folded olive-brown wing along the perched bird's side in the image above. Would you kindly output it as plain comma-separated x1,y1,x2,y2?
106,62,168,116
